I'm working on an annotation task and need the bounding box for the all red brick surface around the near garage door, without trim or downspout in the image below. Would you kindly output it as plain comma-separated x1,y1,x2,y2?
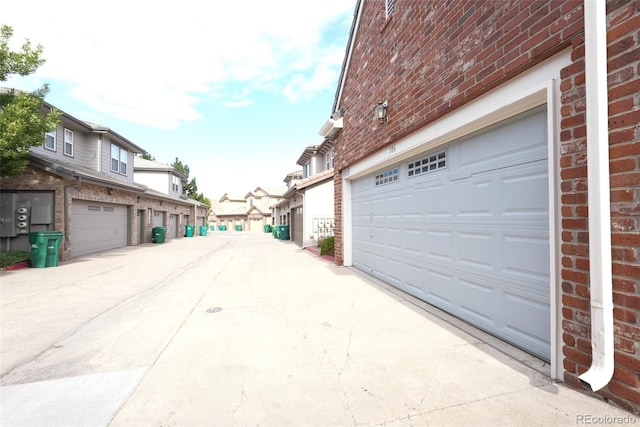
334,0,640,413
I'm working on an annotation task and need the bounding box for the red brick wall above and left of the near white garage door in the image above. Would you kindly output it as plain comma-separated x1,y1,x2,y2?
334,0,582,263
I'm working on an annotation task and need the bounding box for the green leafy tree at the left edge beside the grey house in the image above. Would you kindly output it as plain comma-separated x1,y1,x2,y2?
0,25,60,176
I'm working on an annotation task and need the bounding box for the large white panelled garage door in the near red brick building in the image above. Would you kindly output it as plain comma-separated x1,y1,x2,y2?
352,108,550,360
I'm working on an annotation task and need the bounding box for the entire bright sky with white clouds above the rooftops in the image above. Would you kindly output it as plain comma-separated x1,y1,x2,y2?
0,0,356,201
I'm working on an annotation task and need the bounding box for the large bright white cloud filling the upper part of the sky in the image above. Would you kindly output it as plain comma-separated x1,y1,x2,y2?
0,0,355,129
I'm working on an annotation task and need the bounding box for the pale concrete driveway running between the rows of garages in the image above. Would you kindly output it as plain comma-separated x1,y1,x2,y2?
0,231,640,427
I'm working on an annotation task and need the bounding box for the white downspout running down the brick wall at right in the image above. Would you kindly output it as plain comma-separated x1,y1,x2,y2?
579,0,614,391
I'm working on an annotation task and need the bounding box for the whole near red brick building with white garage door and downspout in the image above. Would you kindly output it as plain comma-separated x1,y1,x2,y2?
332,0,640,414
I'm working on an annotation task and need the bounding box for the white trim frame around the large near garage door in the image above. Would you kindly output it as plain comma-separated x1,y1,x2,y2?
342,51,571,378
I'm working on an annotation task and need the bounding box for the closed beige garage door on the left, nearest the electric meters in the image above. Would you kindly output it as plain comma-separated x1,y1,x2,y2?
71,200,129,256
